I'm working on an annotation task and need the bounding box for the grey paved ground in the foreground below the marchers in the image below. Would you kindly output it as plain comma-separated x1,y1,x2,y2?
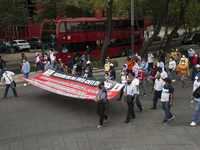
0,70,200,150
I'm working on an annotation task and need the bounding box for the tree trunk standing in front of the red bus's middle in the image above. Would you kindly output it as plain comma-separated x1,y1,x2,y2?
100,0,113,66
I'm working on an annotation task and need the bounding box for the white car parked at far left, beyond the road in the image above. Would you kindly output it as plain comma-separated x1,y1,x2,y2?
7,40,31,52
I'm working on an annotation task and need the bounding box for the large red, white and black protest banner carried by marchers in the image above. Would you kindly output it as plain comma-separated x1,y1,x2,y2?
20,69,124,100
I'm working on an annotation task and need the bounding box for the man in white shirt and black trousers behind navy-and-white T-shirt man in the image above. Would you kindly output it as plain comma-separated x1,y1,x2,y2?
151,73,164,110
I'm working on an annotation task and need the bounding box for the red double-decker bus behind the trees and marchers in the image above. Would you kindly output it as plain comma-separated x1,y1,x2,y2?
41,18,144,64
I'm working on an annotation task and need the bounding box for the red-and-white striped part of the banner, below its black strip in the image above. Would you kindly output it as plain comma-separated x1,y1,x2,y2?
19,69,123,100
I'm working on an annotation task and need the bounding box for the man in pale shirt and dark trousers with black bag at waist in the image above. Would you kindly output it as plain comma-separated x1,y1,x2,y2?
122,78,137,123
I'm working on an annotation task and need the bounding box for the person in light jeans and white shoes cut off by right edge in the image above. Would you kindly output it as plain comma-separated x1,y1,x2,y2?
190,72,200,127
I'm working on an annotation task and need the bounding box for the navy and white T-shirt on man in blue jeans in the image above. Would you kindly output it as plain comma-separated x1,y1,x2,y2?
160,84,174,102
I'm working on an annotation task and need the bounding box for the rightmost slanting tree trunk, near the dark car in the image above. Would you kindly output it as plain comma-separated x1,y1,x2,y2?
163,1,188,52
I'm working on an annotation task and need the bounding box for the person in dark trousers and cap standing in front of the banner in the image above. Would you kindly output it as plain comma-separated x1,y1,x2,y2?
94,82,109,129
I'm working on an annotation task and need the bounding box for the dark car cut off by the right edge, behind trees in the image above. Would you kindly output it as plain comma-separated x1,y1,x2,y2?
181,33,200,44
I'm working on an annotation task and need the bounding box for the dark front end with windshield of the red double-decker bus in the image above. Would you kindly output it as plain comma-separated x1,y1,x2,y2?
42,22,58,54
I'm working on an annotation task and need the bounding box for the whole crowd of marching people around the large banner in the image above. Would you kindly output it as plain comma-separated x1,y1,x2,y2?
0,46,200,128
